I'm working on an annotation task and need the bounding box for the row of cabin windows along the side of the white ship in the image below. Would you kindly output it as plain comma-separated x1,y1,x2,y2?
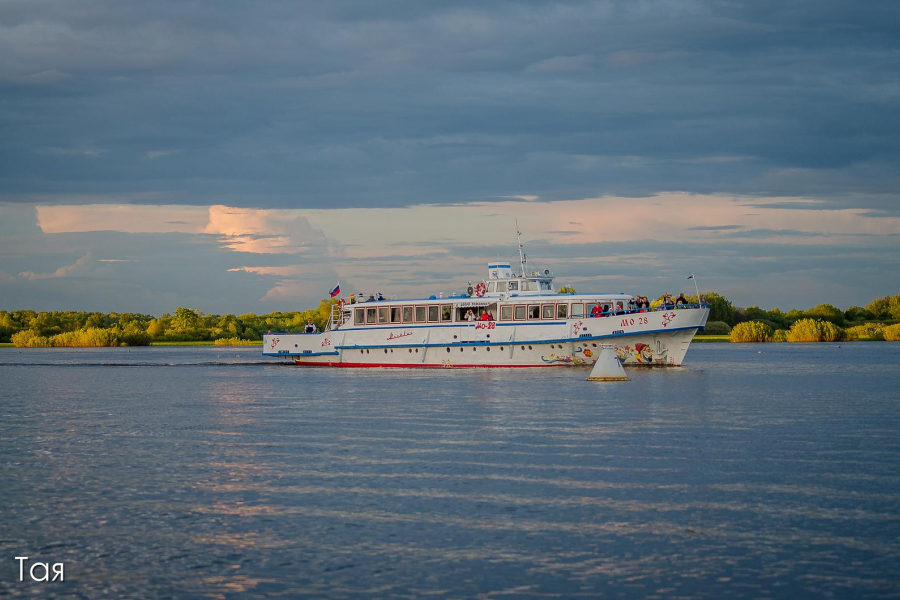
353,302,595,325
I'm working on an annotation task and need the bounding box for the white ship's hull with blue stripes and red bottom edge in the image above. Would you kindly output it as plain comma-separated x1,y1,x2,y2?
263,306,709,368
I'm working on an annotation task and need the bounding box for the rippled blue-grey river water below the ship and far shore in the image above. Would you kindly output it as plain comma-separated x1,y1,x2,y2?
0,343,900,598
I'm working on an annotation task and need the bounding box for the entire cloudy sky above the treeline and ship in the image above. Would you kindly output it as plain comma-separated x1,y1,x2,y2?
0,0,900,315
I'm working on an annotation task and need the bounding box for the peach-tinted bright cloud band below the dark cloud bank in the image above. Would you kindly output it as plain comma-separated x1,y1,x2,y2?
7,193,900,312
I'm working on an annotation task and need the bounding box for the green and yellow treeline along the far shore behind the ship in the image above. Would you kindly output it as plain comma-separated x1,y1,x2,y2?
0,289,900,347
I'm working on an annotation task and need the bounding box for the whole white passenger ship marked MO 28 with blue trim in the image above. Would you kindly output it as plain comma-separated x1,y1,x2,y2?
263,245,709,367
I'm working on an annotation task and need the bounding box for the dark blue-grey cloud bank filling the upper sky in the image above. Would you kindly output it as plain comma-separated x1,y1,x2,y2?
0,0,900,212
